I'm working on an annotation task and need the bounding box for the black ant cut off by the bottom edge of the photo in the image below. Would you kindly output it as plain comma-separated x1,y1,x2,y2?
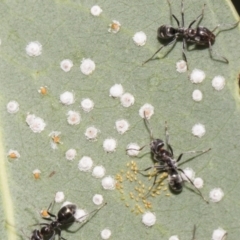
26,203,107,240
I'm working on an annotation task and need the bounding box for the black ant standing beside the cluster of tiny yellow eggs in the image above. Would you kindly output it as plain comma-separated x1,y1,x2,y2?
134,112,211,203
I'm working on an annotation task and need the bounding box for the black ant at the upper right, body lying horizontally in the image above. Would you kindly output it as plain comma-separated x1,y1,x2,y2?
143,0,239,69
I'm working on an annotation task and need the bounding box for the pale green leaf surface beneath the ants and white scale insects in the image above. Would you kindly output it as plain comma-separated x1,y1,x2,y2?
0,0,240,240
